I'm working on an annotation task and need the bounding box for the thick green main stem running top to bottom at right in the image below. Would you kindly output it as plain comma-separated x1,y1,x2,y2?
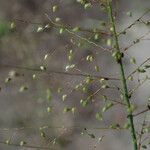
107,0,138,150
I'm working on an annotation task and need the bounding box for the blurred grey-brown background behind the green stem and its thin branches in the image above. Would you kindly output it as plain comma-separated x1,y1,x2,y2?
0,0,150,150
